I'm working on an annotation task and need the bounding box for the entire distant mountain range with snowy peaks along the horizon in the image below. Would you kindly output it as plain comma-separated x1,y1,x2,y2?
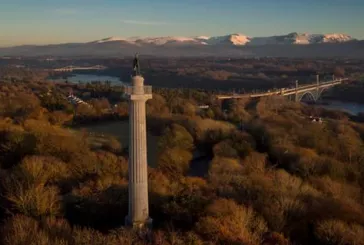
0,32,364,58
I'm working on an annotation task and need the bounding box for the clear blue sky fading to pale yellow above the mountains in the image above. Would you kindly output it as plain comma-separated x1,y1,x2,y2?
0,0,364,47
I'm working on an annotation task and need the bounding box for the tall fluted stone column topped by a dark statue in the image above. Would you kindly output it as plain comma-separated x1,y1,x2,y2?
125,56,152,228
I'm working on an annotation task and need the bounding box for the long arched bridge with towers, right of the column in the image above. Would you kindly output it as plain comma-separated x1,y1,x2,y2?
216,76,349,102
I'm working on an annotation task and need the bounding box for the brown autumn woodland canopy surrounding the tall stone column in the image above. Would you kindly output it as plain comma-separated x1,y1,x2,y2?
0,69,364,245
